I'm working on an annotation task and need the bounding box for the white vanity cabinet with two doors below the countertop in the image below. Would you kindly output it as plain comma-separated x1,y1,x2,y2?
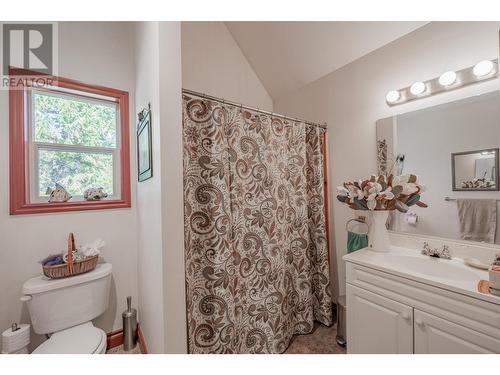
346,262,500,354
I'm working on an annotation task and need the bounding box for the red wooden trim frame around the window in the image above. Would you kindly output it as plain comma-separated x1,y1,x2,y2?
9,68,131,215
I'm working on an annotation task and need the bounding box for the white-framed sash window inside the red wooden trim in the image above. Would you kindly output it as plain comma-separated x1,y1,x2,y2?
31,88,120,202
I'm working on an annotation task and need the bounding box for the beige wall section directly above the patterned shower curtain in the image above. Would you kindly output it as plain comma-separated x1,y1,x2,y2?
182,22,273,111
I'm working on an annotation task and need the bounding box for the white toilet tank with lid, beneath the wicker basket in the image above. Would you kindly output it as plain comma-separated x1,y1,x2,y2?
21,263,112,334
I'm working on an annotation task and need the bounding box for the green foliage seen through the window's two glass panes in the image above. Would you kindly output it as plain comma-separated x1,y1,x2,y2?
32,92,117,196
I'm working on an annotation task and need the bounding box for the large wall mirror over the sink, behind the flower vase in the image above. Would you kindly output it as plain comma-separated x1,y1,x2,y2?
377,91,500,244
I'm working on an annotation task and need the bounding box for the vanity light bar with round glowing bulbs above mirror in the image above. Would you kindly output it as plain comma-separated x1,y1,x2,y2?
385,59,498,107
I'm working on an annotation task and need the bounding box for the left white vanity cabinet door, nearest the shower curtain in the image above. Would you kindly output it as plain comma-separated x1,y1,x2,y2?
346,284,413,354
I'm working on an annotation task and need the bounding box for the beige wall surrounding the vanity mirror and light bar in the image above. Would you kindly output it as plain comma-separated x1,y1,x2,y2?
274,22,500,302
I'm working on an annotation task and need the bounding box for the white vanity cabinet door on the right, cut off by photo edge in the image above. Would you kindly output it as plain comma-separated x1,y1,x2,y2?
414,310,500,354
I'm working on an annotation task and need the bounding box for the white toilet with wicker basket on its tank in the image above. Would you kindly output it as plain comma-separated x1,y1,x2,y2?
21,263,112,354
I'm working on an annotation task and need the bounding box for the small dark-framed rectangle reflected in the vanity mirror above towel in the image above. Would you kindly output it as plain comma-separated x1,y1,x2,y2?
451,148,498,191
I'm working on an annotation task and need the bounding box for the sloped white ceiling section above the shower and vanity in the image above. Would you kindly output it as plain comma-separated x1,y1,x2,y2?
226,22,426,99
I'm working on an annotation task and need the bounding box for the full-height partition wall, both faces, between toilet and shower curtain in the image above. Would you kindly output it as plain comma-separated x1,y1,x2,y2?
135,22,187,353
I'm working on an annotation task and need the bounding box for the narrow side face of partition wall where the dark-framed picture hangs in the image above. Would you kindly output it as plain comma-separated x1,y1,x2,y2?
134,22,165,353
